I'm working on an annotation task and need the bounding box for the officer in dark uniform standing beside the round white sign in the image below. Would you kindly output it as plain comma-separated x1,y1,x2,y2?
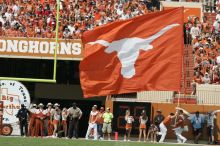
16,104,29,136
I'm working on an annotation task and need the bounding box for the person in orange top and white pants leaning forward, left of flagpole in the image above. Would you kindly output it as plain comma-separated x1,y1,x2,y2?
158,113,176,143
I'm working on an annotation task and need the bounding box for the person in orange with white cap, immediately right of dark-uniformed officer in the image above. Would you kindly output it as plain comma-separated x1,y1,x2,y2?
28,104,37,137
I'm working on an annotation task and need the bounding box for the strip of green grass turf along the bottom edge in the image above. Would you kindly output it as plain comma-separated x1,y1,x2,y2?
0,137,195,146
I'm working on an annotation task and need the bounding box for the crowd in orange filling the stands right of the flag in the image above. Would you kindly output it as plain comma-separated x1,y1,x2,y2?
185,10,220,84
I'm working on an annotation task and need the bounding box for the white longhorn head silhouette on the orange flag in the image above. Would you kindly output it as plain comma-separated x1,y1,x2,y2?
88,24,180,79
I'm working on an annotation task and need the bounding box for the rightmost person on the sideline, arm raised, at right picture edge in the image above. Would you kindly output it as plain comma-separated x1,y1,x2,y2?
205,110,220,144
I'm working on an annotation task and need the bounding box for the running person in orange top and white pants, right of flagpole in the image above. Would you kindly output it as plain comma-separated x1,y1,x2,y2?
172,110,187,143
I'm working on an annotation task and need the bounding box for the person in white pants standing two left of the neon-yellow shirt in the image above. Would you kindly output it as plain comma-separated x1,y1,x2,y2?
86,105,98,140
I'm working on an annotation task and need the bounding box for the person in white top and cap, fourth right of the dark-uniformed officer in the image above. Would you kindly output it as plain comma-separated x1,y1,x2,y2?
51,103,61,138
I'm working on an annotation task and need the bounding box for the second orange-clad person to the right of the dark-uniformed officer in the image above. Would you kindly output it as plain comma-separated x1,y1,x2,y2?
35,103,46,137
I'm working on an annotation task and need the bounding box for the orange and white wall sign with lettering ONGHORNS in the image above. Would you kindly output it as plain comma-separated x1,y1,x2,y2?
0,37,83,60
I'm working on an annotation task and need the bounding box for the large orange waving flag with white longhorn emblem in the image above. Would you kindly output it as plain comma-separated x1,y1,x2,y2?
80,8,183,97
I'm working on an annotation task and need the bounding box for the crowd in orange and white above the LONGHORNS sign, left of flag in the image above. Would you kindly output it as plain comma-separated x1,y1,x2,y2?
0,0,160,39
